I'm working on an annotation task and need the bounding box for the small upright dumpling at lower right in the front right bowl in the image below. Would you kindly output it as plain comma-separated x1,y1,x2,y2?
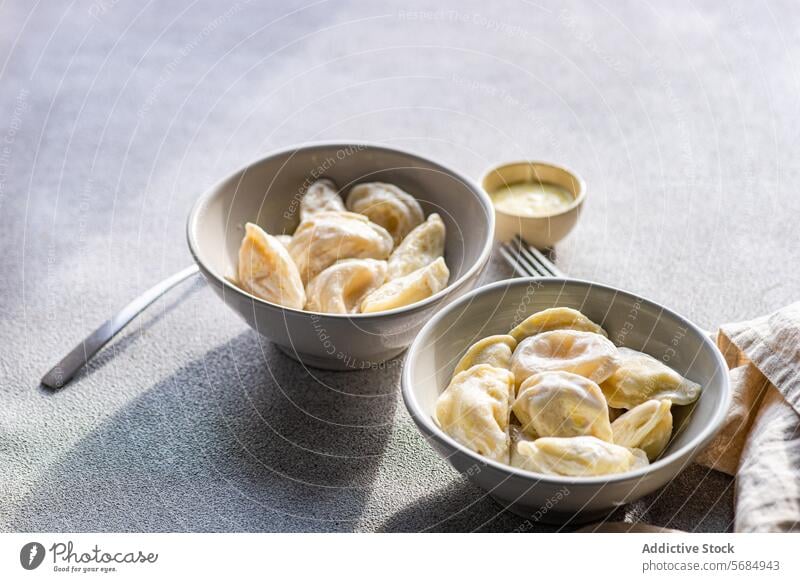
611,400,672,461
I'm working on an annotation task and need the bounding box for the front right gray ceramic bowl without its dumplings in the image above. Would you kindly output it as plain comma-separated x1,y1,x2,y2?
402,279,731,523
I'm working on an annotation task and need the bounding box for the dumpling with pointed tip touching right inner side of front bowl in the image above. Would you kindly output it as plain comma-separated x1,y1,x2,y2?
600,348,701,409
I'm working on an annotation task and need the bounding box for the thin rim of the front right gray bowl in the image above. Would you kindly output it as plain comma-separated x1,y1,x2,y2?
401,277,732,485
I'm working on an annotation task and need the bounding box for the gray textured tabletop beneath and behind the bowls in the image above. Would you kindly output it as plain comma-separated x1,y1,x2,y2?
0,0,800,531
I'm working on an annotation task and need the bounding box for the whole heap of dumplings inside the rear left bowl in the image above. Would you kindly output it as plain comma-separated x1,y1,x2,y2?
236,178,450,314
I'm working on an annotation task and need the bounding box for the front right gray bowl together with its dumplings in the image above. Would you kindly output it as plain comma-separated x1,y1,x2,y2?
402,278,731,524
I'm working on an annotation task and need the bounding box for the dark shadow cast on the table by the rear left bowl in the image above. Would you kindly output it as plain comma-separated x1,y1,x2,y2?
12,332,400,531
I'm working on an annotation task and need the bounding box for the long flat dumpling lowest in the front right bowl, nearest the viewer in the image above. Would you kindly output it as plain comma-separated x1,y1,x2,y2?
515,436,648,477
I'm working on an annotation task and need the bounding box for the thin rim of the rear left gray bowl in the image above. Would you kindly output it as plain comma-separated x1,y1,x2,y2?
186,140,495,320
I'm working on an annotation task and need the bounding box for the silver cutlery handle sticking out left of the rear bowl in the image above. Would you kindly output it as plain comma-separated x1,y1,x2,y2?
42,265,199,390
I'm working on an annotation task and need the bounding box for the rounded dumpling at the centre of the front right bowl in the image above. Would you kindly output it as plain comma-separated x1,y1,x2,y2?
511,372,615,442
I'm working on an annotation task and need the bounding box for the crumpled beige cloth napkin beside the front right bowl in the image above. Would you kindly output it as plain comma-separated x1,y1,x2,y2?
697,302,800,532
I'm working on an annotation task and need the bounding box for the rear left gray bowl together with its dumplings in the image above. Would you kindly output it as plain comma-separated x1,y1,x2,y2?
187,143,494,370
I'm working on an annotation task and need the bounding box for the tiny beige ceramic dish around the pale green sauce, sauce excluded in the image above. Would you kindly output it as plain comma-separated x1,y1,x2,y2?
481,161,586,249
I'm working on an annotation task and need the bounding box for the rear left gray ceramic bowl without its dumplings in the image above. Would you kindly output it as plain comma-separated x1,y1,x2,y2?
187,143,494,370
